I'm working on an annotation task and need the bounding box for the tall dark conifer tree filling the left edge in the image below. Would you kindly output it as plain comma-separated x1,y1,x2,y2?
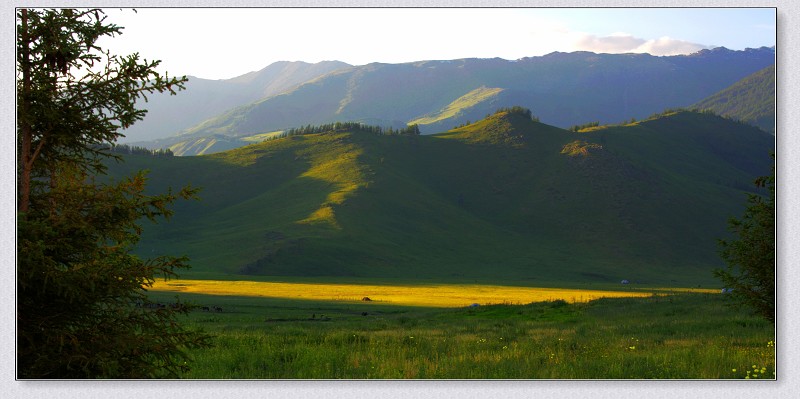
17,9,210,379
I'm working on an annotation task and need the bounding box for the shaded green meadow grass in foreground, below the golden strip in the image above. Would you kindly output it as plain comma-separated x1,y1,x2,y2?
145,293,775,379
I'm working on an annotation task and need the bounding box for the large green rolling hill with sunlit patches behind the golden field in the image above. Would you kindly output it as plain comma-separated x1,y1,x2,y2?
112,111,772,285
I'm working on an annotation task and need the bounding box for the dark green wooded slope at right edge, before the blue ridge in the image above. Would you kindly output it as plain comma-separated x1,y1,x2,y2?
692,65,775,134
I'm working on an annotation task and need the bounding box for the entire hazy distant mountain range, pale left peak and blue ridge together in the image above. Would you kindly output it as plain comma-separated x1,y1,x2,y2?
129,47,774,155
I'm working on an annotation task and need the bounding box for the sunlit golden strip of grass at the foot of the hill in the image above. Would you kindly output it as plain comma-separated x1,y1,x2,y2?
151,279,716,308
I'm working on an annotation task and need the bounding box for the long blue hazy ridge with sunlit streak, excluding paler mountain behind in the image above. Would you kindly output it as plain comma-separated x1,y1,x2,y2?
173,48,774,141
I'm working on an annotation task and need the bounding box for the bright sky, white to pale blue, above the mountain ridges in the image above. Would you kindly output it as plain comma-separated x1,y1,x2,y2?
102,8,776,79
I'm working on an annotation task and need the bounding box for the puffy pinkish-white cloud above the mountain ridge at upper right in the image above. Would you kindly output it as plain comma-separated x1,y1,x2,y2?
572,32,709,55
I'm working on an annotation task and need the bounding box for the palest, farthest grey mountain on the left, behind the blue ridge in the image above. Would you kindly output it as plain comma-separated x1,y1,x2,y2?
119,61,350,144
